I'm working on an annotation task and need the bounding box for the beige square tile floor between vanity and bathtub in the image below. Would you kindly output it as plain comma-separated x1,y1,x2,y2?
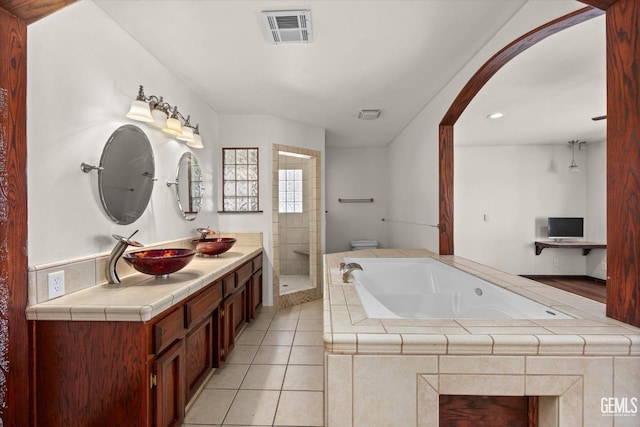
183,300,324,427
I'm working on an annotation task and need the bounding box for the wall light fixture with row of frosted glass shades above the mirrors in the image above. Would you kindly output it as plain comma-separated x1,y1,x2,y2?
127,85,204,148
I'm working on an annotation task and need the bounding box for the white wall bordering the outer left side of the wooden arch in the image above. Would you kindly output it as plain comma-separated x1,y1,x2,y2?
389,1,582,252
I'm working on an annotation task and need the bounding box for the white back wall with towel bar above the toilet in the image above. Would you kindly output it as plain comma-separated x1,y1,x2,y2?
326,147,390,253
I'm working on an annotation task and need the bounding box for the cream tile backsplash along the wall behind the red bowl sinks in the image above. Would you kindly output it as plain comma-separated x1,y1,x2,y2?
29,232,262,314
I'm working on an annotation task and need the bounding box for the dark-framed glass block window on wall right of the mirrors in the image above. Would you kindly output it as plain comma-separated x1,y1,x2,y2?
222,148,259,212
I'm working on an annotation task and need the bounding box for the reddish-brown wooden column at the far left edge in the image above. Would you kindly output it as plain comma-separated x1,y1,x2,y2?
0,5,30,426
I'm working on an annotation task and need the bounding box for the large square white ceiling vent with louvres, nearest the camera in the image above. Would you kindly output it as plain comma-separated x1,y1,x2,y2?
262,10,311,44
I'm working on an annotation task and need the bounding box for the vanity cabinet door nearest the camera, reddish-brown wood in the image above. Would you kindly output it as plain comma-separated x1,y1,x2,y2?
153,340,185,427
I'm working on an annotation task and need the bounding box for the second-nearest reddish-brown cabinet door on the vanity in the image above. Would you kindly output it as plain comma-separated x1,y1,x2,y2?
185,315,214,402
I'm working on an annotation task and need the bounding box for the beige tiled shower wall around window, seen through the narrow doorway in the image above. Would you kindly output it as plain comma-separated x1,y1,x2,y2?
278,156,309,275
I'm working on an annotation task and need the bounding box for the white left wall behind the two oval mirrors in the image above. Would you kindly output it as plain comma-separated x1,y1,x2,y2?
27,2,219,265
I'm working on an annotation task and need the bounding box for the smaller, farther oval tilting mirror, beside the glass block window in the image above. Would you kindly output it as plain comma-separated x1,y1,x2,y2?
168,152,204,221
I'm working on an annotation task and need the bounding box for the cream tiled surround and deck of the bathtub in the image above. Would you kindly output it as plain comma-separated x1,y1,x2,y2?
324,249,640,427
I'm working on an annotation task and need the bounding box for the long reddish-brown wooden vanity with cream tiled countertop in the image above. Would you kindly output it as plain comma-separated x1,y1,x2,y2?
27,246,262,426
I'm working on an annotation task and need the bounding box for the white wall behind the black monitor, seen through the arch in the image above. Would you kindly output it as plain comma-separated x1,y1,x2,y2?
454,144,594,275
